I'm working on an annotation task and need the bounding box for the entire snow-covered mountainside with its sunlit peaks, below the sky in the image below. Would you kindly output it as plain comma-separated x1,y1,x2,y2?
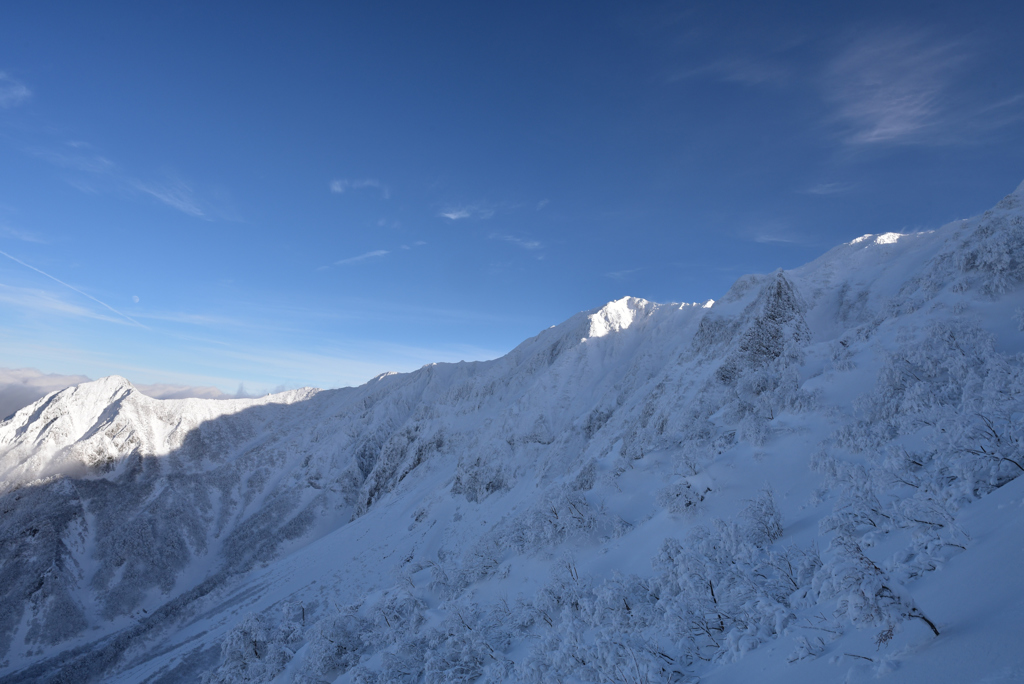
0,185,1024,683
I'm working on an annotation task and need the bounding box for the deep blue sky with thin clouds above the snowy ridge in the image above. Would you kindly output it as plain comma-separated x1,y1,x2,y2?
0,1,1024,391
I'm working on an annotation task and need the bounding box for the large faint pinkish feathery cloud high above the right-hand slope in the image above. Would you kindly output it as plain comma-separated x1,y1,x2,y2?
825,32,965,144
